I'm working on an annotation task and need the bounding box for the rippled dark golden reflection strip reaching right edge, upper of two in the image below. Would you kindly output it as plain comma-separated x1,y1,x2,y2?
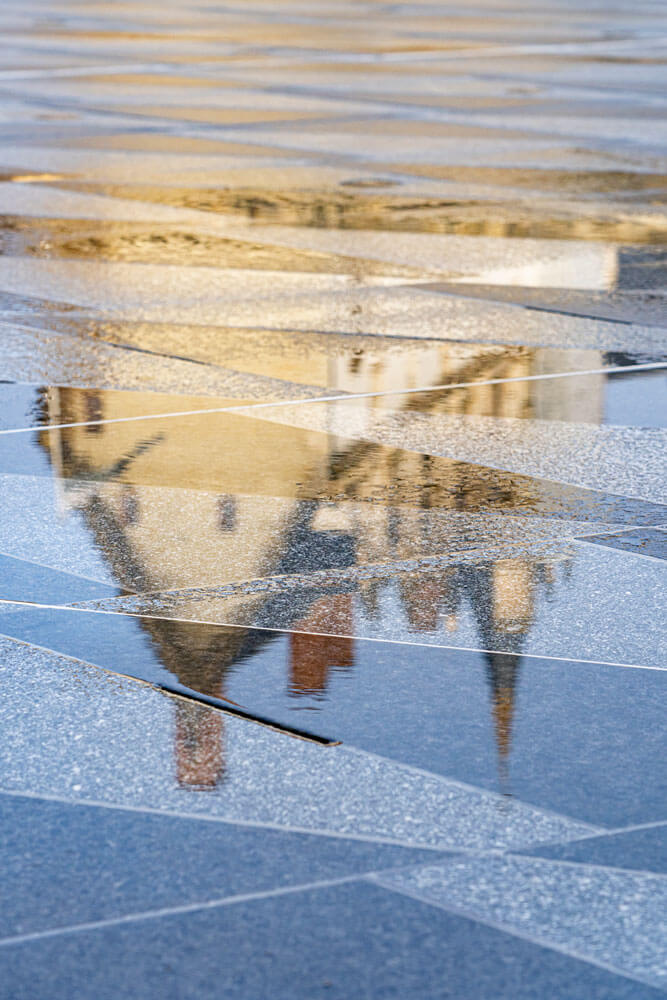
54,181,667,244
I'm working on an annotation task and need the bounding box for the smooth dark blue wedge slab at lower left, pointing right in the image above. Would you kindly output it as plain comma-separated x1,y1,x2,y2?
0,793,444,936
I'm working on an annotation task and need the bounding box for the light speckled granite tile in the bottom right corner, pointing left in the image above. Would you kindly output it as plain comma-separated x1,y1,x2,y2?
377,857,667,989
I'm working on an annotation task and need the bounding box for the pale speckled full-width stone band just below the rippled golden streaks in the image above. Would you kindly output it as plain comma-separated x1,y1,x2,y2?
0,257,664,354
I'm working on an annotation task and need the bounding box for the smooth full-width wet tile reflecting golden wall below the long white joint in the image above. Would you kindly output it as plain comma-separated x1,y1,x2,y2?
0,402,661,525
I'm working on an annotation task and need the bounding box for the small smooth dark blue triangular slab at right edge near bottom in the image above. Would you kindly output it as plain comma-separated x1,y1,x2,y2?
528,820,667,875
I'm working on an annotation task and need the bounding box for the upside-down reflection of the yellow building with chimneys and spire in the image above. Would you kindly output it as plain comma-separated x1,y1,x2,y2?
41,345,599,788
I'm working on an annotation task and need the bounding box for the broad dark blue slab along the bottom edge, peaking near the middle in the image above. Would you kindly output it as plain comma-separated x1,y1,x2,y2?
0,883,664,1000
